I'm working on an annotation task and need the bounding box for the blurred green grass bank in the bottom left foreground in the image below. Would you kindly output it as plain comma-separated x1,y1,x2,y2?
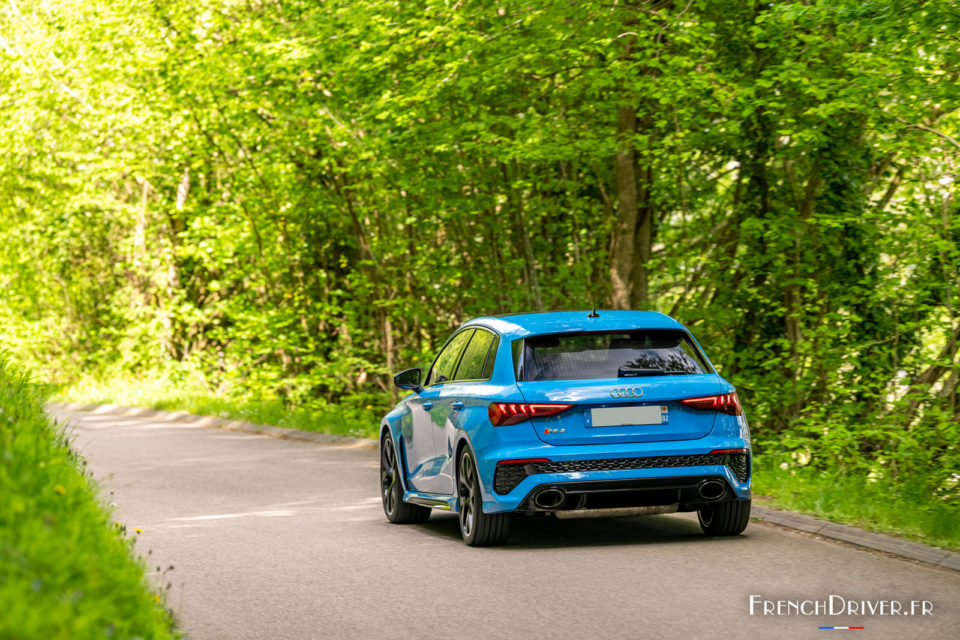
0,359,179,640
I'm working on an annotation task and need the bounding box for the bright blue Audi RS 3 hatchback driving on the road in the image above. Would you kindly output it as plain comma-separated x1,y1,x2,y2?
380,310,751,546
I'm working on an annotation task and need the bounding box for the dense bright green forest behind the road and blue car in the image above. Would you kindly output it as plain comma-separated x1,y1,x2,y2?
0,0,960,545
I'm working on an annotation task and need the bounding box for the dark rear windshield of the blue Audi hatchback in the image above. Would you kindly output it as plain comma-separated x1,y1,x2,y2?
514,330,712,381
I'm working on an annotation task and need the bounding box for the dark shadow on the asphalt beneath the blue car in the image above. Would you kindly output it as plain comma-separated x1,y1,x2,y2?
416,512,749,549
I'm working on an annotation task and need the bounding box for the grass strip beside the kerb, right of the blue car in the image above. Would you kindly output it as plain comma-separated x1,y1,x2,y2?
753,456,960,551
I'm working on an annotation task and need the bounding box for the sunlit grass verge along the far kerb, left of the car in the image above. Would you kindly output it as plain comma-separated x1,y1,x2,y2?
54,374,384,438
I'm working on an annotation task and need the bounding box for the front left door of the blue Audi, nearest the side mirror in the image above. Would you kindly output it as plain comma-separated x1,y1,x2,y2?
404,328,474,493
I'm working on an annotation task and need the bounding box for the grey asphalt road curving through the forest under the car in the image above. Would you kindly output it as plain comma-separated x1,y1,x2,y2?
50,412,960,640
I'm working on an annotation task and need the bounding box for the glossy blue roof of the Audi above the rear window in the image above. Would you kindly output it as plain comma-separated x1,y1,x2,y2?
464,309,684,338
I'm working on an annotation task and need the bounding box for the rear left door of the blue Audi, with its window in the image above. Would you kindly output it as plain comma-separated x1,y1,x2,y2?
434,328,499,495
